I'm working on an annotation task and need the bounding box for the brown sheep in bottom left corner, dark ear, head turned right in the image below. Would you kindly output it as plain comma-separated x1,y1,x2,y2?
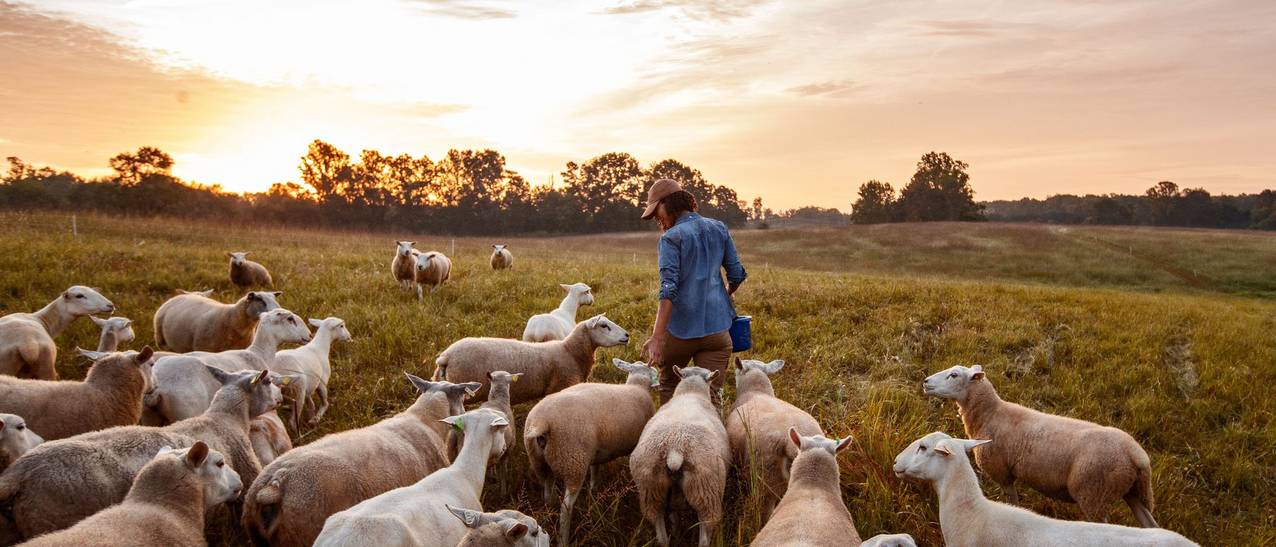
24,441,244,547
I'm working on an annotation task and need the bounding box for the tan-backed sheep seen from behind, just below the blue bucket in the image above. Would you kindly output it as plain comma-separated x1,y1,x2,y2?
726,358,824,519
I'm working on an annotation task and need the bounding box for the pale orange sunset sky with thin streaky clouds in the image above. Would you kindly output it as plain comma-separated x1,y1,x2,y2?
0,0,1276,210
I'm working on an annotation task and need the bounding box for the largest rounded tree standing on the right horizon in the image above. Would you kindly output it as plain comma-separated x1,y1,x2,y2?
898,152,985,221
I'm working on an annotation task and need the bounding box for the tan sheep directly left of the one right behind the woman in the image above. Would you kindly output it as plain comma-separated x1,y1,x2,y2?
523,358,660,547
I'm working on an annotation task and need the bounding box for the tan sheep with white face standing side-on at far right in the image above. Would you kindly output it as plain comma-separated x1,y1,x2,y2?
921,365,1156,528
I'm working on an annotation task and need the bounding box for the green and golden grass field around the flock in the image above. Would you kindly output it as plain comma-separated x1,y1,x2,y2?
0,213,1276,546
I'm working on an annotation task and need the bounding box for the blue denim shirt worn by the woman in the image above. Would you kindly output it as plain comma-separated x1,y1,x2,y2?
660,212,748,339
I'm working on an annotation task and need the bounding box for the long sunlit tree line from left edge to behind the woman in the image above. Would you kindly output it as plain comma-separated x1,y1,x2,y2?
0,140,750,235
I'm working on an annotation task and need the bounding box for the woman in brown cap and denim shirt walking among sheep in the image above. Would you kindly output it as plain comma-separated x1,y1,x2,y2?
642,179,748,407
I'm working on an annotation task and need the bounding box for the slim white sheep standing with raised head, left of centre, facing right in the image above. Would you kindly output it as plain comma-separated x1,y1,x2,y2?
269,317,351,432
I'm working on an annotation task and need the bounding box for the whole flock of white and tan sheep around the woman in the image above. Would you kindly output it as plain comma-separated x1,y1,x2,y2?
0,241,1194,547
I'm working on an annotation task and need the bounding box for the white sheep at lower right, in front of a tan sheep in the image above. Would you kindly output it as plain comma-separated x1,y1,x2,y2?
894,431,1196,547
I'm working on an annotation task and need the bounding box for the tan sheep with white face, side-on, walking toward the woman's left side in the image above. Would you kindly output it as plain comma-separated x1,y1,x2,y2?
434,315,629,404
